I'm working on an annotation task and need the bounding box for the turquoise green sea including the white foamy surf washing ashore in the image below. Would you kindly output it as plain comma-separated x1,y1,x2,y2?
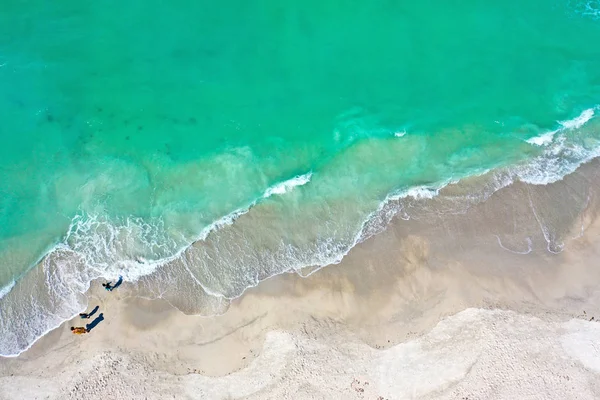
0,0,600,355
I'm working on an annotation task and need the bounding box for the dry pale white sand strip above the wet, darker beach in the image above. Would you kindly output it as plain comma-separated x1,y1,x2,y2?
0,300,600,399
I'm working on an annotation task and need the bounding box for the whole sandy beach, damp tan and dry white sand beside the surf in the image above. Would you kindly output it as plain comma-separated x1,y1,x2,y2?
0,162,600,400
